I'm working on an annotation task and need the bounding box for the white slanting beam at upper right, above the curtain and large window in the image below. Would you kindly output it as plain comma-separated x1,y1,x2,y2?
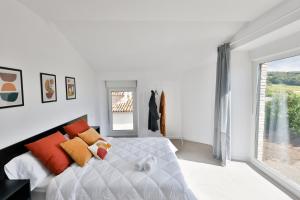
231,0,300,49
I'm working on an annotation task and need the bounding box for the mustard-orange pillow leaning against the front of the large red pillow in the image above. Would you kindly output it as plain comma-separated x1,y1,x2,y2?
60,137,92,167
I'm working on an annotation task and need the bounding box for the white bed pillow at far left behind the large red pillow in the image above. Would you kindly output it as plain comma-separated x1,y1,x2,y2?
4,152,50,190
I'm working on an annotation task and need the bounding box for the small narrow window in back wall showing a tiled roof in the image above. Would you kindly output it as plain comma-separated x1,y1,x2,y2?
106,81,137,136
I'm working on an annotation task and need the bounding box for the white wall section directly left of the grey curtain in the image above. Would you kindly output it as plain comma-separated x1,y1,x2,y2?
182,63,216,144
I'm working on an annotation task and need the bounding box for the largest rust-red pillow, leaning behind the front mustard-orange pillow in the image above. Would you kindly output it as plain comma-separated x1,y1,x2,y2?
25,131,71,175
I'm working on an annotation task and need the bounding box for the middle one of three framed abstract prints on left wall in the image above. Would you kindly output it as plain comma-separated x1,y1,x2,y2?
40,73,57,103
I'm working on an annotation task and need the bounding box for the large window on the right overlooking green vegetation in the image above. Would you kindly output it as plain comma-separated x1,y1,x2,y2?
256,56,300,186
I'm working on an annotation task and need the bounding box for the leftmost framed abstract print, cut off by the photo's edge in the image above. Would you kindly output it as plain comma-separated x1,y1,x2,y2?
0,67,24,109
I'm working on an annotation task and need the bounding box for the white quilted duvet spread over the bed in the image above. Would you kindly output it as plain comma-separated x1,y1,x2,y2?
46,138,196,200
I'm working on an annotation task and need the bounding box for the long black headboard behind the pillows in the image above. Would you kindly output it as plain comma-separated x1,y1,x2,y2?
0,115,87,180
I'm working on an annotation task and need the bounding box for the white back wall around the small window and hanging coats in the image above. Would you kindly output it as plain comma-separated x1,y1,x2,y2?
97,71,182,138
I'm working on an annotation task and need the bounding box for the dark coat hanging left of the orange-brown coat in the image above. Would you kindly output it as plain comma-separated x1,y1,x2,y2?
148,90,159,131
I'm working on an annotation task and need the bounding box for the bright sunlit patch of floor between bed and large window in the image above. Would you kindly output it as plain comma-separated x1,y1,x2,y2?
178,159,291,200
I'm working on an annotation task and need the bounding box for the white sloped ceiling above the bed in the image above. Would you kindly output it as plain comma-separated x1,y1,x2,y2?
18,0,282,71
